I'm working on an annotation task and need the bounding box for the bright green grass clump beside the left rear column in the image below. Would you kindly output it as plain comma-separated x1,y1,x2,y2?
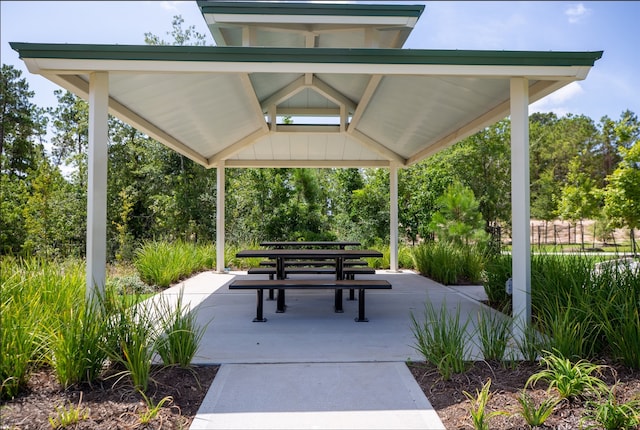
134,241,216,288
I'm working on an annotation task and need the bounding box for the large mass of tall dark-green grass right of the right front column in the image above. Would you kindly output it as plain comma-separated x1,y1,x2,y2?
531,255,640,368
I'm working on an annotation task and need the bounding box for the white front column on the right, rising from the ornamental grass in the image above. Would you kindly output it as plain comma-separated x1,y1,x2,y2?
511,78,531,338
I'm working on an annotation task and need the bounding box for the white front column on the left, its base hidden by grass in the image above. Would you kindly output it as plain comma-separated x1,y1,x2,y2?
86,72,109,300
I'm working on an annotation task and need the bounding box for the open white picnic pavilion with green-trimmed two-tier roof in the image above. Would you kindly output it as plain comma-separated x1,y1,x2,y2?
11,1,602,332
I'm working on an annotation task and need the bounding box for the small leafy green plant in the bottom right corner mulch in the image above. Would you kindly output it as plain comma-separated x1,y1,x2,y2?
583,386,640,430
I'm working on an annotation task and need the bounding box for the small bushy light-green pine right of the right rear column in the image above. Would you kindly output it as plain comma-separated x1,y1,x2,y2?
430,181,488,245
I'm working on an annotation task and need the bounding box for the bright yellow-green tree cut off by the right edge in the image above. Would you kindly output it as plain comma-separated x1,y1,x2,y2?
605,140,640,254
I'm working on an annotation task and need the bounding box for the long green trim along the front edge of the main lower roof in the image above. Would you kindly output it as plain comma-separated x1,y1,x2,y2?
9,42,603,66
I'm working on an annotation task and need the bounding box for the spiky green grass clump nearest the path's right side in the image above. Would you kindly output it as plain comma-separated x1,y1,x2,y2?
411,301,469,380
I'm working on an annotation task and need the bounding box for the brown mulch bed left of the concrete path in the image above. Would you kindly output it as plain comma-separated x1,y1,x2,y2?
0,366,218,430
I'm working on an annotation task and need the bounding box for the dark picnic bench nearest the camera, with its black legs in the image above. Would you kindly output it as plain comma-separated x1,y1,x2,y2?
229,279,391,322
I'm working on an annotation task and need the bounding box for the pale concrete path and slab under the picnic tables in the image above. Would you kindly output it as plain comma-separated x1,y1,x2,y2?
163,271,484,430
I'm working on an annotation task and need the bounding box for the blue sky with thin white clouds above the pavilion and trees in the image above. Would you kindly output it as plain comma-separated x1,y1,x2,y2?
0,0,640,122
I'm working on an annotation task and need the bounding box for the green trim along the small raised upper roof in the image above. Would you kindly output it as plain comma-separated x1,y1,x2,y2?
198,1,424,18
